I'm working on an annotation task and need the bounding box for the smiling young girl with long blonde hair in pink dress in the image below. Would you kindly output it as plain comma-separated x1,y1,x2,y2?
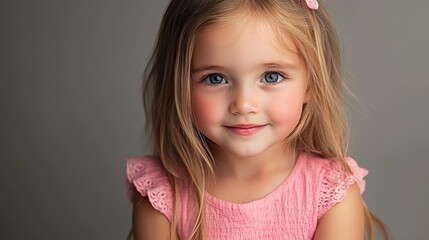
127,0,388,240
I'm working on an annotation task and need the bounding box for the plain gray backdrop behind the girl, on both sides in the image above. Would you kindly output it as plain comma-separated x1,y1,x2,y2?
0,0,429,239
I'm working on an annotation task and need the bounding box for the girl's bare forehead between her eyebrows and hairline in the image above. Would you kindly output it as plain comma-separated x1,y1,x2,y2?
192,18,301,69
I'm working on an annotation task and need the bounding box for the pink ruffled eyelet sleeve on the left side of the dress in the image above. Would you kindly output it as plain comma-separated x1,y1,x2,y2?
127,157,173,221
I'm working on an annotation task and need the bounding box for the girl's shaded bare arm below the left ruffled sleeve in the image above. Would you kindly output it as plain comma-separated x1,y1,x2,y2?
133,197,178,240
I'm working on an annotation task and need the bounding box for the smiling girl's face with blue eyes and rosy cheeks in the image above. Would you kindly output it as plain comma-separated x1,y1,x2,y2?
191,17,309,158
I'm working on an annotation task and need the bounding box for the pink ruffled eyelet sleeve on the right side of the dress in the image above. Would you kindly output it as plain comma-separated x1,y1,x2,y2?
317,157,368,219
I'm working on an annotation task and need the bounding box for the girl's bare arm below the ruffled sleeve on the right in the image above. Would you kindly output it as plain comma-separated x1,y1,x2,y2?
313,184,365,240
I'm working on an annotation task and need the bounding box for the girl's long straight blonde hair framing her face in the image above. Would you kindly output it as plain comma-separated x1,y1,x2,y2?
143,0,387,239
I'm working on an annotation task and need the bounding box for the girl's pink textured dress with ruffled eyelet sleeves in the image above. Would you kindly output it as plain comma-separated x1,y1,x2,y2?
127,153,368,240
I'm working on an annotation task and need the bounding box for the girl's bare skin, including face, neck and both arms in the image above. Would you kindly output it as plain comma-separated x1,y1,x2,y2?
133,16,364,240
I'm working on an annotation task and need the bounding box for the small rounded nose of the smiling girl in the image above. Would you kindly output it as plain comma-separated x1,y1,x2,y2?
228,87,258,115
